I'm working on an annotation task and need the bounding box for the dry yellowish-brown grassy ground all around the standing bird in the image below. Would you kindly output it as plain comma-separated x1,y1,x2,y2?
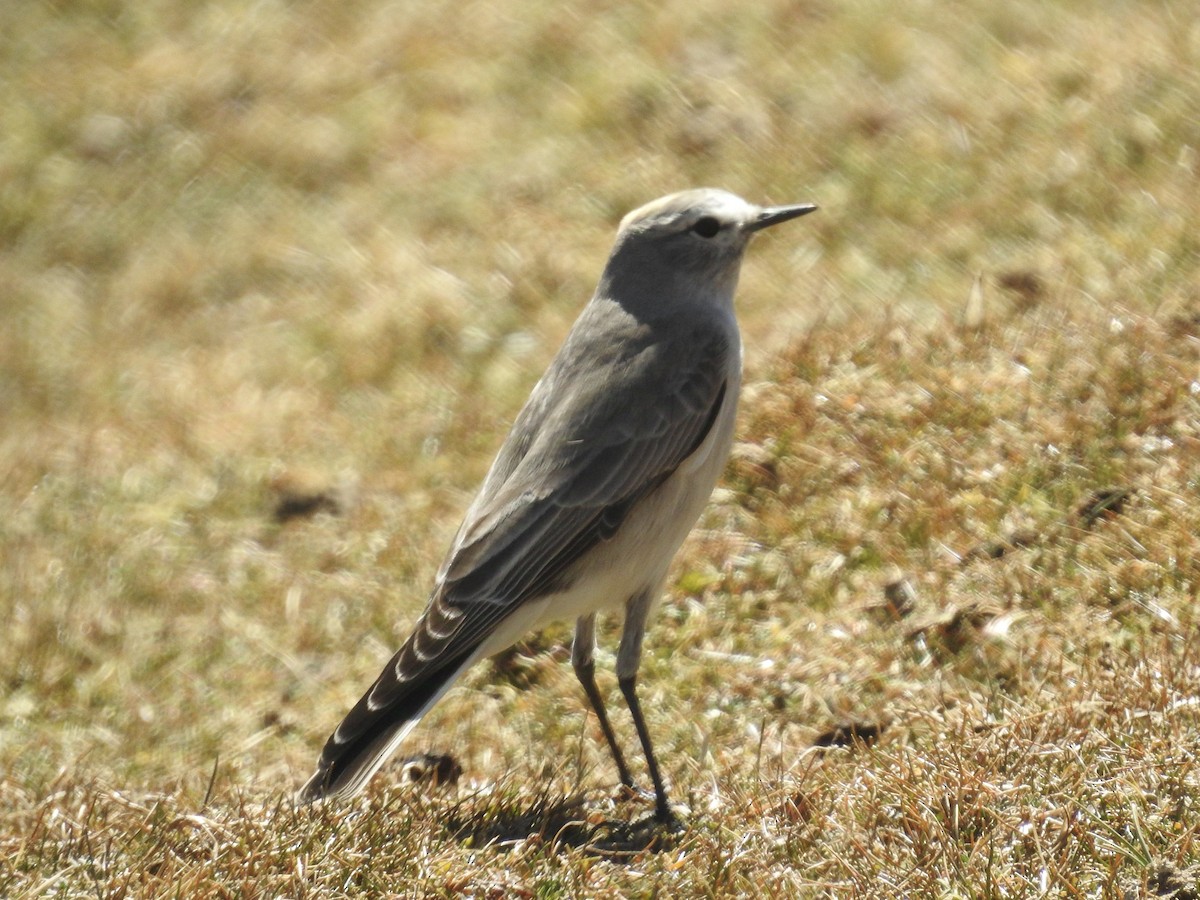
0,0,1200,898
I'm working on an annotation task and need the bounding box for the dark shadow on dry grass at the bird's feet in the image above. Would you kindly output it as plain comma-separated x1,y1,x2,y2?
445,796,682,862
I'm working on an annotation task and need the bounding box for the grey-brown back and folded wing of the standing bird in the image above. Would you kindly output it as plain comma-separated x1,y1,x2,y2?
372,314,733,704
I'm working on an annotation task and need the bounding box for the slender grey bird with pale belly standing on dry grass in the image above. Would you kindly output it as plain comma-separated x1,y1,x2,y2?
296,188,817,822
